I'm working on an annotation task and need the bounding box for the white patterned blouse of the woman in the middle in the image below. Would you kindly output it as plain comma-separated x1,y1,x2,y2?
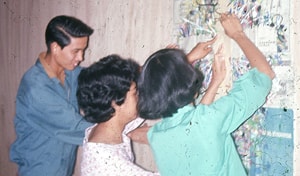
81,118,160,176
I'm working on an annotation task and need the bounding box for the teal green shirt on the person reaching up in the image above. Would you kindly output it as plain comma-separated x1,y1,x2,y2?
148,69,272,176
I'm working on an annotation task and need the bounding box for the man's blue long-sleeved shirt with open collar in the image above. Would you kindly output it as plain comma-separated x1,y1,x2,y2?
10,59,92,176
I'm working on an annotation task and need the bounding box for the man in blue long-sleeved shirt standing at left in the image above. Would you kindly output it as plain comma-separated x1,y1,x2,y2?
10,16,93,176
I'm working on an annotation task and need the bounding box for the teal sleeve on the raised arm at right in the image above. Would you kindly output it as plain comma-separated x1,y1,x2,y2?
211,68,272,133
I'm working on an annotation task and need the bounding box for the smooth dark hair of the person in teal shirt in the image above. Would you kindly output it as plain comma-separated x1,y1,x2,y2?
138,49,204,119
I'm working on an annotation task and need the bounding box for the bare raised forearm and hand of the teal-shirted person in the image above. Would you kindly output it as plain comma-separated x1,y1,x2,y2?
220,13,275,79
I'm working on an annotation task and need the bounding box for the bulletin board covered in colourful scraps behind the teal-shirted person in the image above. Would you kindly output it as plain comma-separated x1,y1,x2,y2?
174,0,295,176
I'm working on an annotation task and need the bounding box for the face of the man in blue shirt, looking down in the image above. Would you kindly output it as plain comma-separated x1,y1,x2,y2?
55,37,88,70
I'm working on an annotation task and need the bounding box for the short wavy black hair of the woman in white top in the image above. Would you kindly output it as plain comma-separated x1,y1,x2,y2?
76,55,140,123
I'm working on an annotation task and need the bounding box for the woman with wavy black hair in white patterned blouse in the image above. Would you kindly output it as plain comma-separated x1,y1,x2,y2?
77,55,159,176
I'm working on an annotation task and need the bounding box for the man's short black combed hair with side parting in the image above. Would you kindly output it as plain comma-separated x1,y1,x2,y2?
45,15,93,52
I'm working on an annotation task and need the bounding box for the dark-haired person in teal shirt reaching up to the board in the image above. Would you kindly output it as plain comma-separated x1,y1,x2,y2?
138,14,275,176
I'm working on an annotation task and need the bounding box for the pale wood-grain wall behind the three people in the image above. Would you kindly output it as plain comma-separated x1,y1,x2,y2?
0,0,300,176
